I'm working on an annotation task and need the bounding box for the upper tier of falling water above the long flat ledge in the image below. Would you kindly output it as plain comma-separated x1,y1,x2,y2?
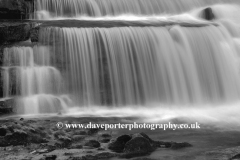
33,0,238,20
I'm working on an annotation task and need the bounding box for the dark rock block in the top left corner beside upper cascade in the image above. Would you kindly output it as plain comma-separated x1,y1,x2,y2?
0,0,34,19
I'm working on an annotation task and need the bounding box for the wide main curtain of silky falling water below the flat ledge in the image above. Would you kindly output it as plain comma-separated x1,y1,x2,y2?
36,26,240,106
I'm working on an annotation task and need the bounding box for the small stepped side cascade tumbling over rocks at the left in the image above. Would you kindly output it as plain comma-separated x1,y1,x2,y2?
2,46,68,114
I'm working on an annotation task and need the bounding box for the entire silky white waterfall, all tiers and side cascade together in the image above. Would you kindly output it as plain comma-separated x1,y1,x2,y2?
1,0,240,117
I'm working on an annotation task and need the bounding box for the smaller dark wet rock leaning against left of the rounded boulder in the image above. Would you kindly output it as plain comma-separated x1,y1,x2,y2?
108,135,132,152
